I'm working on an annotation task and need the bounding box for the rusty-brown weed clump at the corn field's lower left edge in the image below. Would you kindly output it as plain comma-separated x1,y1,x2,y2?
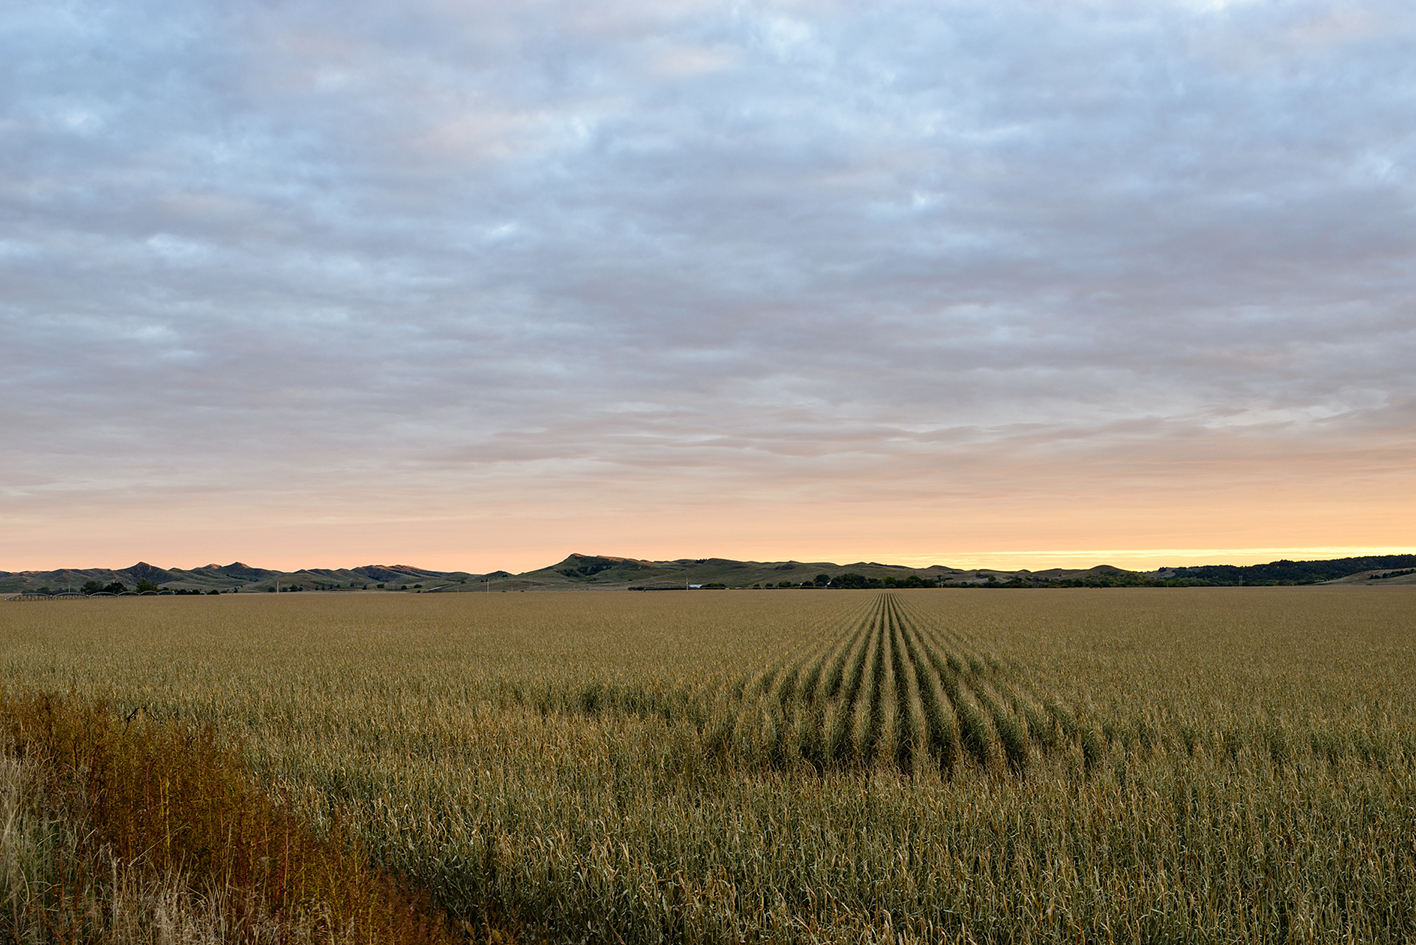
0,693,466,945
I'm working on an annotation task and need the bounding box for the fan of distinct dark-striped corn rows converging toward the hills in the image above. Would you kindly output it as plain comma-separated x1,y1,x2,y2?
705,594,1081,774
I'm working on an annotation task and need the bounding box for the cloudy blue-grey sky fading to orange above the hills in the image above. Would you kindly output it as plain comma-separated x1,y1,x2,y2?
0,0,1416,572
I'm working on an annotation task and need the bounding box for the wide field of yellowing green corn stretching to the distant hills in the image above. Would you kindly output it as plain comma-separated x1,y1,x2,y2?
0,588,1416,942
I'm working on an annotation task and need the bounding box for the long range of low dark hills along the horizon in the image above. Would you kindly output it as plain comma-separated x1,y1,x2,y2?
8,554,1416,595
